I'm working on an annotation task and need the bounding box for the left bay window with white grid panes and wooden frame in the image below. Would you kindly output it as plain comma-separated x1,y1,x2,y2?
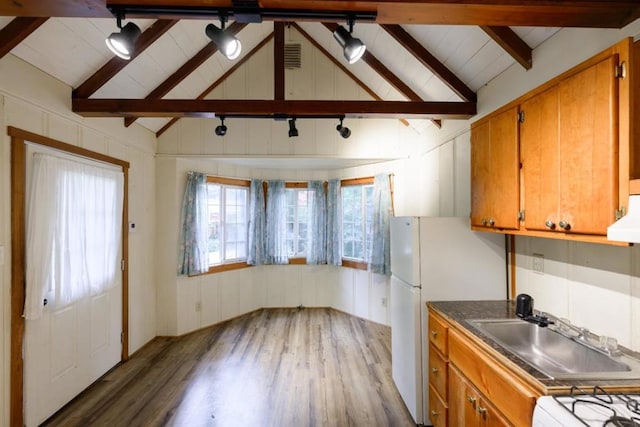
207,177,249,266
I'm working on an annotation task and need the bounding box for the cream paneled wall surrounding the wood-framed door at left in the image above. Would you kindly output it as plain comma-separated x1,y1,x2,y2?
0,54,156,425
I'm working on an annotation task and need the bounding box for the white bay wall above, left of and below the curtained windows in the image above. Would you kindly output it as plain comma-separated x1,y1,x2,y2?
156,158,408,335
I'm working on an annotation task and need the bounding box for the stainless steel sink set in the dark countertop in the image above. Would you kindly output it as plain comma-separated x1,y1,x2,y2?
468,319,640,379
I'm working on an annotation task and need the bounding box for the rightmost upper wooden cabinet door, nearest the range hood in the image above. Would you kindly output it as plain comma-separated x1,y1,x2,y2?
559,55,618,234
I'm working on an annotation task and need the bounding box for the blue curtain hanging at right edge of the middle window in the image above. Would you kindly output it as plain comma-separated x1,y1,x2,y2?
307,181,327,264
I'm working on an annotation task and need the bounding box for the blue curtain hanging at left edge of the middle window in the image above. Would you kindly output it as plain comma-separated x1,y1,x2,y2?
265,180,289,264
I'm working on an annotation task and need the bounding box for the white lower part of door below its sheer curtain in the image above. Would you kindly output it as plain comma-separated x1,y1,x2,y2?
24,146,122,426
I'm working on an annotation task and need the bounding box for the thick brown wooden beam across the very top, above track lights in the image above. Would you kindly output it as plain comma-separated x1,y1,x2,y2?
0,0,640,28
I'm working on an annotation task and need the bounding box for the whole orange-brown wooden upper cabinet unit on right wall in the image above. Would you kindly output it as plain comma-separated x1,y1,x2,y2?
471,39,640,243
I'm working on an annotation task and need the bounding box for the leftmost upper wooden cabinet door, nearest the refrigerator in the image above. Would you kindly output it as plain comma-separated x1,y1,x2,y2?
471,107,520,229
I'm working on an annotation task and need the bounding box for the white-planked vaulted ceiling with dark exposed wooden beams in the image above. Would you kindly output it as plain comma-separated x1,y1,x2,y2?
0,0,640,134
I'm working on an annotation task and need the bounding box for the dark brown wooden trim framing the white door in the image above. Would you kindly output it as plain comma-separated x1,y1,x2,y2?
7,126,129,427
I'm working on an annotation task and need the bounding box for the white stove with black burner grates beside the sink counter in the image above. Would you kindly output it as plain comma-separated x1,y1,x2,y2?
532,387,640,427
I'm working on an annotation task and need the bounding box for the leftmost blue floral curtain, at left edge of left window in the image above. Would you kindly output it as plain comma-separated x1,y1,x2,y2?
178,172,209,275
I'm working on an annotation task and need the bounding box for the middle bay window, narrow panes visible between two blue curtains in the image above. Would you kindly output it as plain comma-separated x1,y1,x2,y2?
286,188,312,258
